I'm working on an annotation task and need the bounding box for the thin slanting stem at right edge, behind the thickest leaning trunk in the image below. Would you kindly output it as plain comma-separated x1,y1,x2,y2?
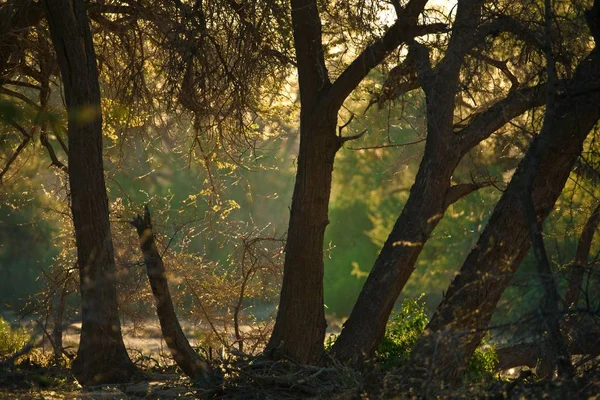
565,204,600,307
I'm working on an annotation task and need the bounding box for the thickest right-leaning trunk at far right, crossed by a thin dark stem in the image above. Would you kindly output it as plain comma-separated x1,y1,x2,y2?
413,50,600,382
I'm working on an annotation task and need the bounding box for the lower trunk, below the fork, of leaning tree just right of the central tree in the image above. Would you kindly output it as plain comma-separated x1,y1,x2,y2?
332,139,459,364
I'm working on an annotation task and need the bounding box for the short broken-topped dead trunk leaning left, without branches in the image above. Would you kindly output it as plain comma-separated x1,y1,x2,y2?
131,206,214,380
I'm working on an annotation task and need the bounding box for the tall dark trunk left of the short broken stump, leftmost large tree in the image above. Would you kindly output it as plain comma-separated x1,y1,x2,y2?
44,0,136,385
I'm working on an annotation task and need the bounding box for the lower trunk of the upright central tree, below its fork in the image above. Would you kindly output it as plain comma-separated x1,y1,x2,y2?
267,116,341,363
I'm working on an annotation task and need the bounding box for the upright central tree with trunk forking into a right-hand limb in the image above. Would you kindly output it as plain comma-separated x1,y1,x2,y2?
267,0,445,362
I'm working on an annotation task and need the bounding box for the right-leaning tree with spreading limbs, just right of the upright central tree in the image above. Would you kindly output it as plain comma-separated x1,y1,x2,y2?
333,0,564,363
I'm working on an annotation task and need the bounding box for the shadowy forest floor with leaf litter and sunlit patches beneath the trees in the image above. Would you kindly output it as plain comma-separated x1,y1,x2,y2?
0,324,600,400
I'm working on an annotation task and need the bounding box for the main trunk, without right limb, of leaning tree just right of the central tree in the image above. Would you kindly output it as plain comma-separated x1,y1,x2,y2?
332,0,490,364
